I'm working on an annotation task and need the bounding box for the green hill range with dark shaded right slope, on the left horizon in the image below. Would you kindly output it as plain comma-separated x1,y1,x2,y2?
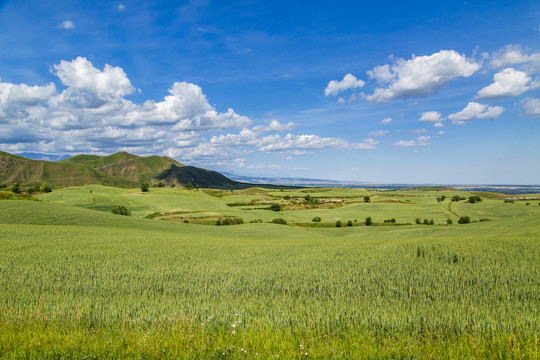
0,151,284,190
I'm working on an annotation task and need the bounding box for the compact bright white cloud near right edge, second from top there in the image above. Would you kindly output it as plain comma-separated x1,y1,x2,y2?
476,68,534,99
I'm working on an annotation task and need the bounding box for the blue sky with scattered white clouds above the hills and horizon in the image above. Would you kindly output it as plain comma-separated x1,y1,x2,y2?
0,0,540,184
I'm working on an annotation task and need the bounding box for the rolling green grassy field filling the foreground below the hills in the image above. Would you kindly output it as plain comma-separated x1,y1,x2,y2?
0,186,540,359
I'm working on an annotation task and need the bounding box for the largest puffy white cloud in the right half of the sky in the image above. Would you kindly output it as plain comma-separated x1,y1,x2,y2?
367,50,480,102
